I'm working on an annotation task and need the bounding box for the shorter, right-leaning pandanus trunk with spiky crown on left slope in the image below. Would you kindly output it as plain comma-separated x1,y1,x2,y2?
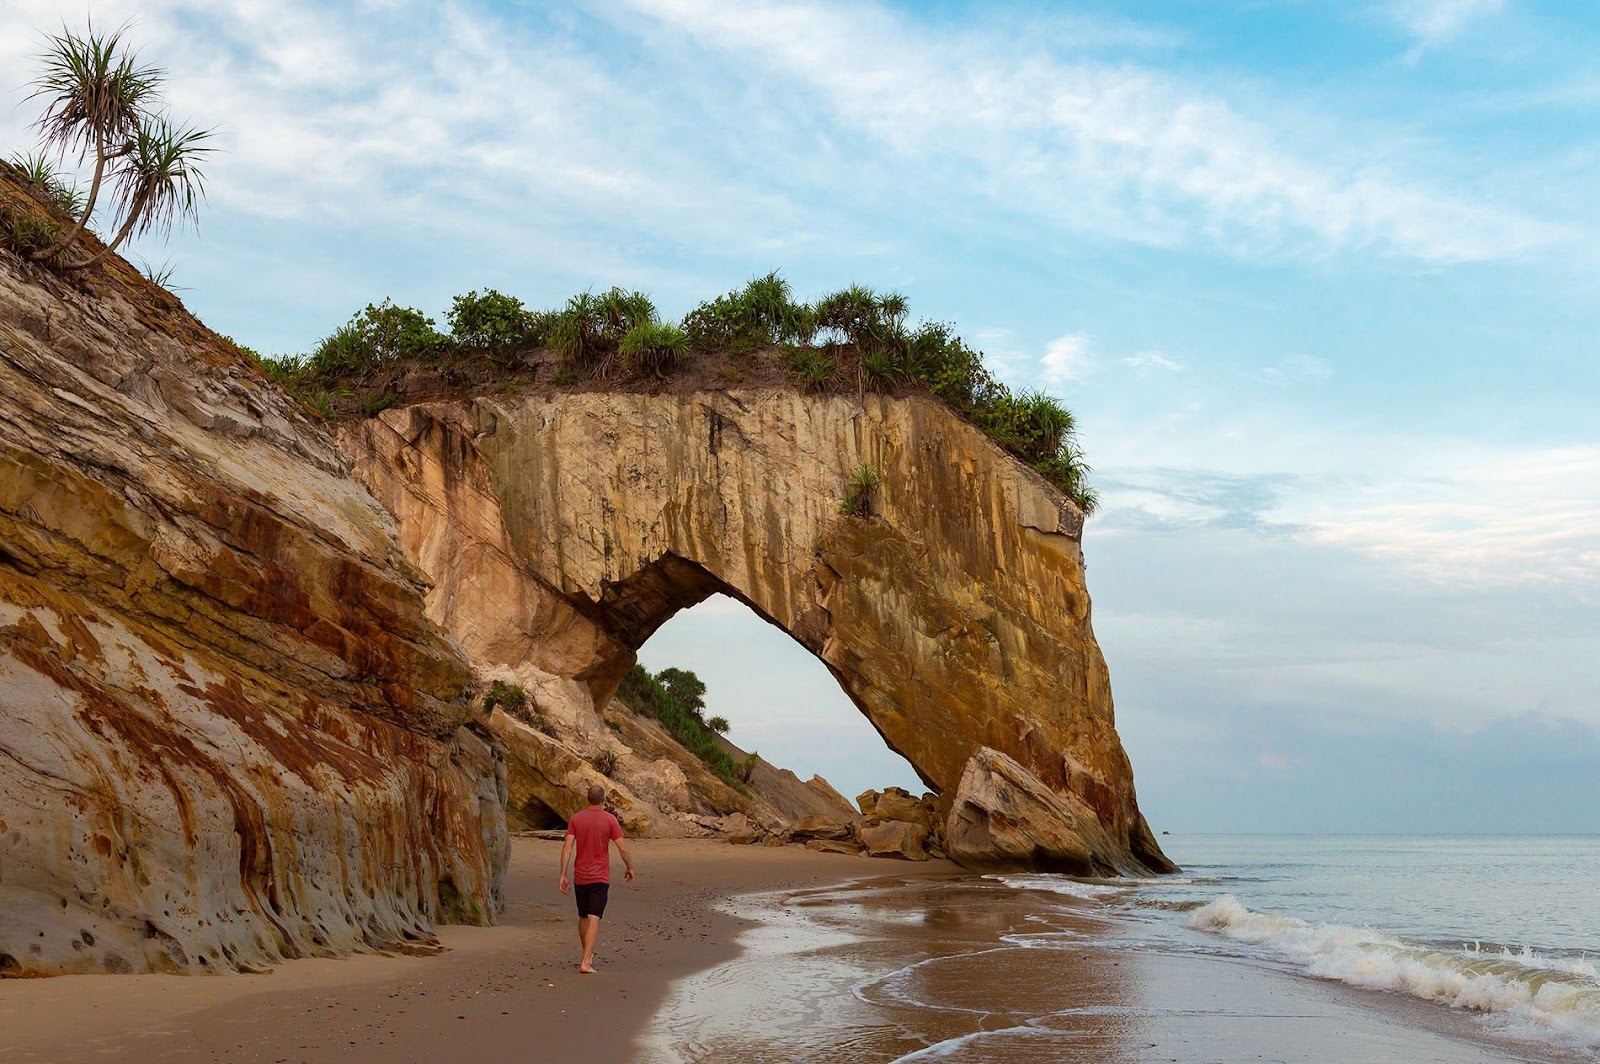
67,117,216,270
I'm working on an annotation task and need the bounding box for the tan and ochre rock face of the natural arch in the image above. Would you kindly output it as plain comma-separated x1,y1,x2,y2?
341,389,1171,874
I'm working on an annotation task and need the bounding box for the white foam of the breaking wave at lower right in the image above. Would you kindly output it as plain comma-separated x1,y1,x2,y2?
1186,894,1600,1050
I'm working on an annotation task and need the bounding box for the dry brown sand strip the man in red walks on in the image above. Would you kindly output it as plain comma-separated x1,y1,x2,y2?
0,837,958,1064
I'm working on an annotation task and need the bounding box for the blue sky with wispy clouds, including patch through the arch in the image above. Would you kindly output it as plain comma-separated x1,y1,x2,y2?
0,0,1600,832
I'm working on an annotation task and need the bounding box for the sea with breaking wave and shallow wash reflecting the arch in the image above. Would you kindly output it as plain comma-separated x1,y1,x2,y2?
645,835,1600,1064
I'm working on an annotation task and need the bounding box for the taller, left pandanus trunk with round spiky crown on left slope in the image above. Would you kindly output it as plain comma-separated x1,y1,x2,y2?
32,24,162,258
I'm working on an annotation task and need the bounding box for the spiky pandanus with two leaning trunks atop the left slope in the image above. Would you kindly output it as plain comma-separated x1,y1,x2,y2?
23,24,213,269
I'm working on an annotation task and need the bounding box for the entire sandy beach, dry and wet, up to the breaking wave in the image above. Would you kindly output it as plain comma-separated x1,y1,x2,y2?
0,838,1550,1064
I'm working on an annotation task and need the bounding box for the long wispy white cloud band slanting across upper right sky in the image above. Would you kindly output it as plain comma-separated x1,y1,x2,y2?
617,0,1566,261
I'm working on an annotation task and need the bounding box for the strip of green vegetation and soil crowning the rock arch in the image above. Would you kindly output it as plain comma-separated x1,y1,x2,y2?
250,274,1099,514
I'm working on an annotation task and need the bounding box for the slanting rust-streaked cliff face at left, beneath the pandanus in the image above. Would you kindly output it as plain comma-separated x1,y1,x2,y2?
0,182,507,974
